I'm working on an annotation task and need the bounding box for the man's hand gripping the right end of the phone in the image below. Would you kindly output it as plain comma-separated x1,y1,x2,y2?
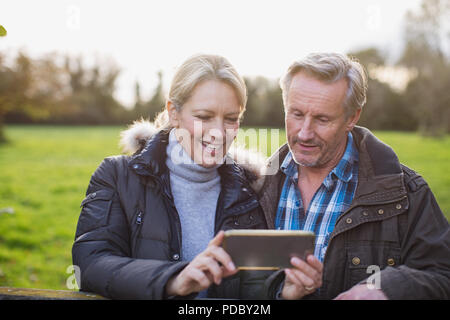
281,255,323,300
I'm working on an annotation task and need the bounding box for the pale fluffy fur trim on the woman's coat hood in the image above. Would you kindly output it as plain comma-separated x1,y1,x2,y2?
119,119,267,192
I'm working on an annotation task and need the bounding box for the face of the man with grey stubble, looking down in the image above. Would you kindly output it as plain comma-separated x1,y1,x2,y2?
285,72,361,168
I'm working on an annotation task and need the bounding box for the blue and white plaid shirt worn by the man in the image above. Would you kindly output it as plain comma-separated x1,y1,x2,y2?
275,133,359,262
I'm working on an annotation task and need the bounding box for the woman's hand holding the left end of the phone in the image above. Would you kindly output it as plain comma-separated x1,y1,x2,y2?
166,231,238,296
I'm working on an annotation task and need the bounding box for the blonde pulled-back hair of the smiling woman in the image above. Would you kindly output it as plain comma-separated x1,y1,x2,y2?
154,54,247,129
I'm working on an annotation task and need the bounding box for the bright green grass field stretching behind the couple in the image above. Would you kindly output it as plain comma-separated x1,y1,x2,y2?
0,126,450,289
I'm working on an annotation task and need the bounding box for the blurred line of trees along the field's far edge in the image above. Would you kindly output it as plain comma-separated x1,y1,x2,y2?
0,0,450,140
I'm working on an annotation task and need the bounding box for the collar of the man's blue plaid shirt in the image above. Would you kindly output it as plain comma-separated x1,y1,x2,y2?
280,132,358,189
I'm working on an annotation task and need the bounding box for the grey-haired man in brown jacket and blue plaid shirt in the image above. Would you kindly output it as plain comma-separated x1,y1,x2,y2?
260,53,450,299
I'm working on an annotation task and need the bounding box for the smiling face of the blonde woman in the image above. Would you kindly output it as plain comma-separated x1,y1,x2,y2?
167,80,241,167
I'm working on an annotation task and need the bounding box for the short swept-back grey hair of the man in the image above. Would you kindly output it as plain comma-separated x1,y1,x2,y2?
280,53,367,116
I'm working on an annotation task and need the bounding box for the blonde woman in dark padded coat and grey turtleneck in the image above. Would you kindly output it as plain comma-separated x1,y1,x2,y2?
72,55,266,299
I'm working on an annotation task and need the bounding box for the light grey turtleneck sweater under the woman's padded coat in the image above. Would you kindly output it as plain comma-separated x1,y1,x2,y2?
166,129,220,261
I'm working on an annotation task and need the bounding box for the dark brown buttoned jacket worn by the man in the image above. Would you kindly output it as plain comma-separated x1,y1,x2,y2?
260,127,450,299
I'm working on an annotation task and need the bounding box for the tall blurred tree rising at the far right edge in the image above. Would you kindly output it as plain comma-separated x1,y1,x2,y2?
399,0,450,136
